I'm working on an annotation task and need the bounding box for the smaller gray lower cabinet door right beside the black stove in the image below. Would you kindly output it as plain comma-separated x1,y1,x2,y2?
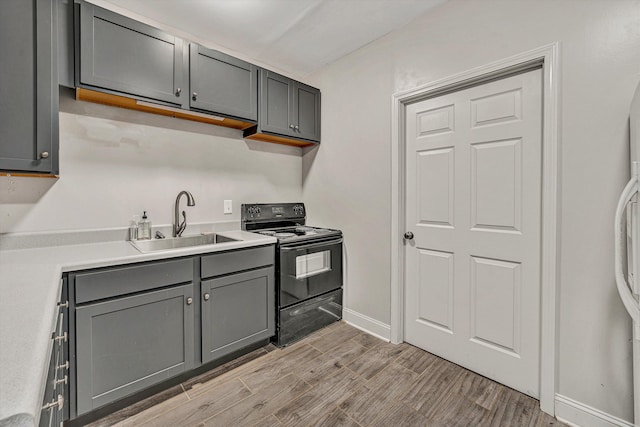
202,267,275,363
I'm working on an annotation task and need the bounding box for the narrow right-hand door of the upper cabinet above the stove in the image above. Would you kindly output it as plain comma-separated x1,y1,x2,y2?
293,82,320,142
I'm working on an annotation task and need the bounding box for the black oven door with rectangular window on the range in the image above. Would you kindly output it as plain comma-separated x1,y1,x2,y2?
279,238,342,307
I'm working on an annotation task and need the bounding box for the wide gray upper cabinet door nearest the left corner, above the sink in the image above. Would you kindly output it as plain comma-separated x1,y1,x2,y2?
79,2,188,107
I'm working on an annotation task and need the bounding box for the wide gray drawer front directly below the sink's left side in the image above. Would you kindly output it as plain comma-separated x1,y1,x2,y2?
75,259,193,304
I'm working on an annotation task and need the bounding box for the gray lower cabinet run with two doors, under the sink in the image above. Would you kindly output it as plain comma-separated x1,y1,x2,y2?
66,245,275,422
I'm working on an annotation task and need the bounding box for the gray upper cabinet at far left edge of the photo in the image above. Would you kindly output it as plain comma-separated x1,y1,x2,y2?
0,0,58,174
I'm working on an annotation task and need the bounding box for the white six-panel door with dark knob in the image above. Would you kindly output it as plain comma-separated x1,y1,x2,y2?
405,70,542,398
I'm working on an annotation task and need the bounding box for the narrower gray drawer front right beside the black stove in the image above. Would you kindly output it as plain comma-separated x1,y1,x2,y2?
200,246,275,278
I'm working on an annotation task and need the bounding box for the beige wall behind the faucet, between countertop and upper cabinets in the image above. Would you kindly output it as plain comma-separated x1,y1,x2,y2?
0,91,302,234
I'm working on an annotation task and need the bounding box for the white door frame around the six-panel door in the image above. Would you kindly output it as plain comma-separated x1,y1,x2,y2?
390,42,560,415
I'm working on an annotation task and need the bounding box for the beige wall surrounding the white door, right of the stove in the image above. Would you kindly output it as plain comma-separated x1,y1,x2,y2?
303,0,640,420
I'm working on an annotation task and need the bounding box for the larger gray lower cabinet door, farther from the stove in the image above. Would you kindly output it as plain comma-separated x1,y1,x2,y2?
75,284,194,415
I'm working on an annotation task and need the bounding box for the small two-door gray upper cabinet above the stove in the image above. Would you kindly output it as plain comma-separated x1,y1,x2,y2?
245,70,320,145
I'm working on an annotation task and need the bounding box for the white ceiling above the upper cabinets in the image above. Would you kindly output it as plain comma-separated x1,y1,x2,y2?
94,0,446,76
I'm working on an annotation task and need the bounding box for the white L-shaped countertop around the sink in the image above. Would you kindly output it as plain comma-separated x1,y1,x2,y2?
0,230,276,426
